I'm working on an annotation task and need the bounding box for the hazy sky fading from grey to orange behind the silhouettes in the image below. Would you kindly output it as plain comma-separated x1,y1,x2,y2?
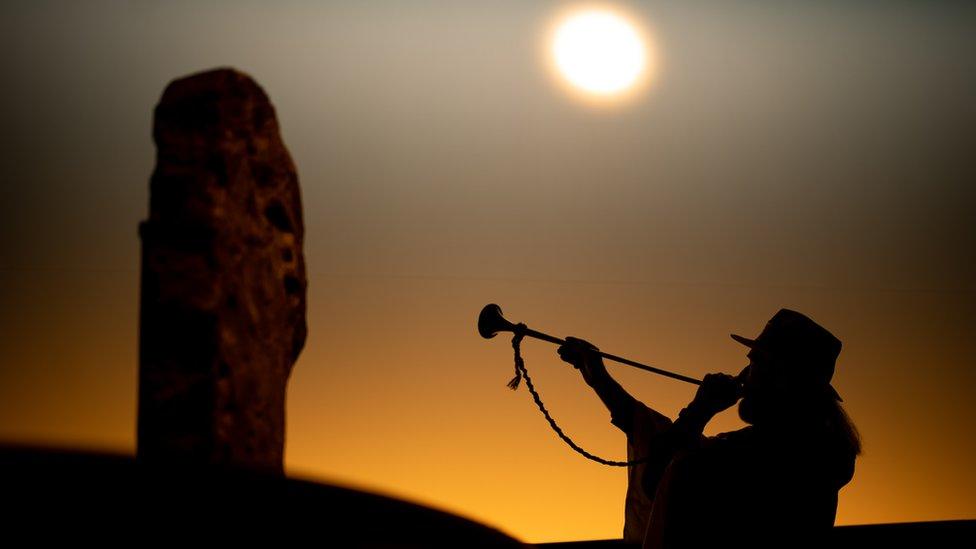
0,0,976,542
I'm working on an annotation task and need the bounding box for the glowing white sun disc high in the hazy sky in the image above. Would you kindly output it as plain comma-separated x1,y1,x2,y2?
552,9,647,96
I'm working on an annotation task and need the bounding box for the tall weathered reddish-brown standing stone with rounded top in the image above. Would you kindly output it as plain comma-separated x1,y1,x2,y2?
137,69,306,472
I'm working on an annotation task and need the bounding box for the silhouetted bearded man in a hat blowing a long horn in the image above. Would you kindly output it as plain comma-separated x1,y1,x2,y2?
558,309,860,548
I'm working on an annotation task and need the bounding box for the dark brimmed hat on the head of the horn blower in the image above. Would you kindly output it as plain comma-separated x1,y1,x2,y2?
730,309,843,400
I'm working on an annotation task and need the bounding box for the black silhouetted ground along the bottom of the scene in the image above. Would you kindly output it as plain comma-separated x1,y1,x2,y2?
0,446,976,549
